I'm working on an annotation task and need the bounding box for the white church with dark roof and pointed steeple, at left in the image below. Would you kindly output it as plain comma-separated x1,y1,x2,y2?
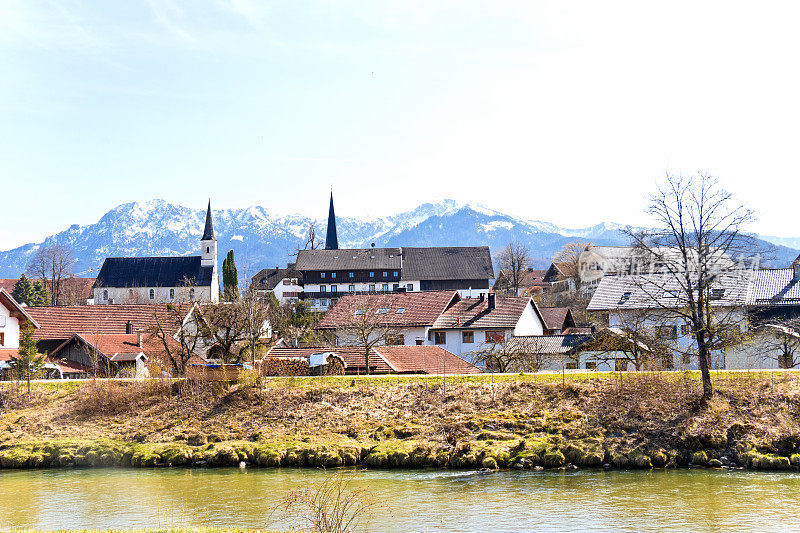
93,200,219,305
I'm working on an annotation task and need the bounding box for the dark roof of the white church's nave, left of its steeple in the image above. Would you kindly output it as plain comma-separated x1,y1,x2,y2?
95,255,213,287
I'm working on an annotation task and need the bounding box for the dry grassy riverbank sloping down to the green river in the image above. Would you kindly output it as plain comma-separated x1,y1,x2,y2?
0,373,800,469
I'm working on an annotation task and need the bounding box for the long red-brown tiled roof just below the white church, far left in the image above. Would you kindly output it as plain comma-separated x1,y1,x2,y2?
25,305,188,340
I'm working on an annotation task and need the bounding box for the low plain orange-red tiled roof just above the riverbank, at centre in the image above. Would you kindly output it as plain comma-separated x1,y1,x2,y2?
375,346,481,374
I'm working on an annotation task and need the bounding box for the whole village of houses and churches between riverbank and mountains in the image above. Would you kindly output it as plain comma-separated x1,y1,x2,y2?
0,187,800,381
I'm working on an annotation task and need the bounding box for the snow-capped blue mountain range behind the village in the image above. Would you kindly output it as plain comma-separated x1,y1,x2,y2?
0,200,800,279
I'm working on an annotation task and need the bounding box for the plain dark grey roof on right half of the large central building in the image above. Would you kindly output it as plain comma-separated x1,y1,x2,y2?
402,246,494,281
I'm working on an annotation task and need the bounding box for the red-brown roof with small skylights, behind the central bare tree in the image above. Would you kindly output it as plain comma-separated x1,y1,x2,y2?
317,291,459,329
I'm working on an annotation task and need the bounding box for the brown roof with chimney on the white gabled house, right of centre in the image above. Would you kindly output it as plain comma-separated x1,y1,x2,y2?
433,296,535,329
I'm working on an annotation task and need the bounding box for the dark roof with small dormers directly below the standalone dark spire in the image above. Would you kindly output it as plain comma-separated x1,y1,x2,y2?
297,248,402,272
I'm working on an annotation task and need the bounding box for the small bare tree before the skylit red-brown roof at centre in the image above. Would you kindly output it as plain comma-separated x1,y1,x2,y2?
337,295,400,374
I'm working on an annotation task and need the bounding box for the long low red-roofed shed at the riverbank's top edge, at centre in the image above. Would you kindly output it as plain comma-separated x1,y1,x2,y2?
265,346,481,375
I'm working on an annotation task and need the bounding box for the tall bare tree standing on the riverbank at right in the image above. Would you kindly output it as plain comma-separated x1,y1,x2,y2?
625,174,754,401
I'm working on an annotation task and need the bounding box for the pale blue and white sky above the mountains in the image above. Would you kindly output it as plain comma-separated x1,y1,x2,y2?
0,0,800,249
